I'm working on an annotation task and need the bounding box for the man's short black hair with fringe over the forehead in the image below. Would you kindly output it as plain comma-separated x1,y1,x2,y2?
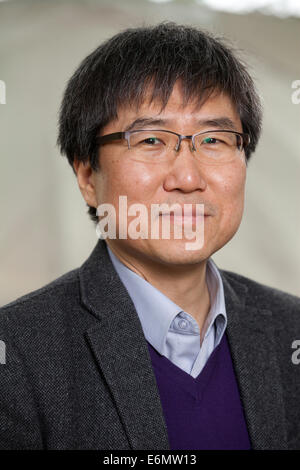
57,22,262,223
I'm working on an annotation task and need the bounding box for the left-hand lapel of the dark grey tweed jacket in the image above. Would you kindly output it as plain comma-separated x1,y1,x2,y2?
79,240,170,450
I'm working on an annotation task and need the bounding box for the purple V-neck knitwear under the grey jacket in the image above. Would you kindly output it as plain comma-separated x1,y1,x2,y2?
148,333,251,450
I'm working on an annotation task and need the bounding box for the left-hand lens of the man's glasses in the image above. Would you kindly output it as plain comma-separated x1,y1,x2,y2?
129,130,178,161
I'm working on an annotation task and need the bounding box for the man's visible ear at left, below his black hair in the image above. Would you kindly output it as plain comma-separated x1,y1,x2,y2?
73,158,98,207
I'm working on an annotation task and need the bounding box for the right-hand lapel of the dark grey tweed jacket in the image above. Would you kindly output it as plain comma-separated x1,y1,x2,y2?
221,271,287,449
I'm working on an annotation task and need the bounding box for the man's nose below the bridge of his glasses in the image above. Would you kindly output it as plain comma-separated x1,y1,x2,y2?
164,140,207,192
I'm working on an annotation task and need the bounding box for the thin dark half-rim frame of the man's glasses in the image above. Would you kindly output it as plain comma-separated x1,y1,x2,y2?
96,129,250,152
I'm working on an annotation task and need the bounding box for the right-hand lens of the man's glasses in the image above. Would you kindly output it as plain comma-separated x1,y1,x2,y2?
195,131,243,164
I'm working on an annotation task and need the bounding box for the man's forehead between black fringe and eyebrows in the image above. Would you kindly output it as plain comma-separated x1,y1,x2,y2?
101,84,242,135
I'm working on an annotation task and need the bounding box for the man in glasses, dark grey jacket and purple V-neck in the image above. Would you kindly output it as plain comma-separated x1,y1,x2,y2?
0,23,300,450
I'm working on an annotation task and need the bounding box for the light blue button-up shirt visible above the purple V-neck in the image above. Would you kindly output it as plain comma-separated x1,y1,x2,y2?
106,244,227,378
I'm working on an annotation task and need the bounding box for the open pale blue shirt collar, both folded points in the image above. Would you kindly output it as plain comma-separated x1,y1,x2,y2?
106,244,227,354
